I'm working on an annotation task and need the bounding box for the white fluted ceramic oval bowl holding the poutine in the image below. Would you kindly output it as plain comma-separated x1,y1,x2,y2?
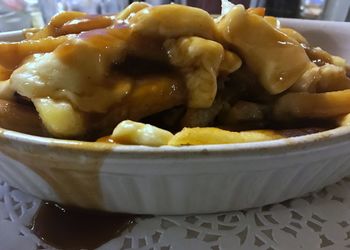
0,20,350,214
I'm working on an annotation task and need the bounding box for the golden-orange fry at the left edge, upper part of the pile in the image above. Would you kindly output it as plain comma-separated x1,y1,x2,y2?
0,36,69,70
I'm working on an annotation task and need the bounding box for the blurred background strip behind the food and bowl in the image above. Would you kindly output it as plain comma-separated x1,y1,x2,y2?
0,0,350,32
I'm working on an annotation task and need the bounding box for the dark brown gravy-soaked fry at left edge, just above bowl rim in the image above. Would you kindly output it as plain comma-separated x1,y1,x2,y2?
0,99,45,136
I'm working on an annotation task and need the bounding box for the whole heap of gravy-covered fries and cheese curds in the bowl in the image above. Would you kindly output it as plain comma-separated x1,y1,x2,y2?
0,2,350,146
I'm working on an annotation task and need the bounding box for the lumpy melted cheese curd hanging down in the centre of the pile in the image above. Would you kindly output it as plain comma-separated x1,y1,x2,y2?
164,37,242,108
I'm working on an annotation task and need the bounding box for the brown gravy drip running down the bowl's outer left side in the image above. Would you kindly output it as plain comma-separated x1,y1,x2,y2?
0,140,109,210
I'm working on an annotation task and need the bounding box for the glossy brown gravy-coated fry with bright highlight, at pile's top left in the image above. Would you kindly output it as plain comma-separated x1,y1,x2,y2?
30,11,115,40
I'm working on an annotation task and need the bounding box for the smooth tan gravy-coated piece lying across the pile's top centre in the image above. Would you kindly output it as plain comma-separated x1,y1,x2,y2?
129,4,216,39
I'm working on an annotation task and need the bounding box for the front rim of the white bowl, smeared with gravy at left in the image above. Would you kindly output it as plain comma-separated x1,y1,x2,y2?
0,126,350,158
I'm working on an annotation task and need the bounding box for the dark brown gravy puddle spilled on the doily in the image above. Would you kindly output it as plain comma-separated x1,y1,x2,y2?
30,202,136,249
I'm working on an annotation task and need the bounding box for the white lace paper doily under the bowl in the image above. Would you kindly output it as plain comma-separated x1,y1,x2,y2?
0,178,350,250
